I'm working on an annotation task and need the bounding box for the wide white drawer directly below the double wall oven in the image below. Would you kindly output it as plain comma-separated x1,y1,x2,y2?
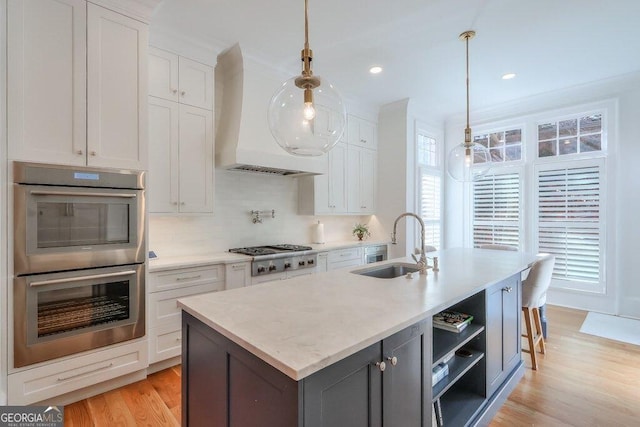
9,340,148,405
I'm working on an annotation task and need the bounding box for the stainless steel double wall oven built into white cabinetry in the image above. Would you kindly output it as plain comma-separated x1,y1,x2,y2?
13,162,146,368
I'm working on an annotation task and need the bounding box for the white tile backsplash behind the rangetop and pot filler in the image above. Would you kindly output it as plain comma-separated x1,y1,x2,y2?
148,170,384,256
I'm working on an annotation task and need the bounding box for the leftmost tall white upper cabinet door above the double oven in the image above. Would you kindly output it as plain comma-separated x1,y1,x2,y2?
7,0,87,165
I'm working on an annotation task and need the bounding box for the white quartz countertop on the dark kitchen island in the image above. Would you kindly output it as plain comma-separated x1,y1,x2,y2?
178,249,535,380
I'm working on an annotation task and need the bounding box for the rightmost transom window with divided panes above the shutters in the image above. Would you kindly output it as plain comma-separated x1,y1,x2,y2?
538,113,602,157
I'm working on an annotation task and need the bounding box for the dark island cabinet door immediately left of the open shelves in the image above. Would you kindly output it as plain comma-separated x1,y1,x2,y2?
382,320,431,427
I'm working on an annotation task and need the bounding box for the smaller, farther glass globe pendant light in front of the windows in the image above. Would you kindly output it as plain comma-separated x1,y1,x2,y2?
447,31,491,182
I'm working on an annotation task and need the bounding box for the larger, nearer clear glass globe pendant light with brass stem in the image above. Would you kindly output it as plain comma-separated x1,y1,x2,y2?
268,0,347,156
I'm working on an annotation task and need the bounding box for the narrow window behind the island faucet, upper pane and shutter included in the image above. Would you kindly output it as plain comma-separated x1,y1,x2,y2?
416,131,442,249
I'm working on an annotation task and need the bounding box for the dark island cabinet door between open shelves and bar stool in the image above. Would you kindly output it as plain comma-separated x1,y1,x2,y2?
486,274,521,397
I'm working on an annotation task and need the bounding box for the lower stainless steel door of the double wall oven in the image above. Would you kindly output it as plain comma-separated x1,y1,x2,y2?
13,264,145,368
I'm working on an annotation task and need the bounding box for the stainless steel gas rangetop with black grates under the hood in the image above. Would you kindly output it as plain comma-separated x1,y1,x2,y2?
229,244,318,277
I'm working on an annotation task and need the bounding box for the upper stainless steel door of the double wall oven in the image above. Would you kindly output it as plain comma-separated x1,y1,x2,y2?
14,184,145,276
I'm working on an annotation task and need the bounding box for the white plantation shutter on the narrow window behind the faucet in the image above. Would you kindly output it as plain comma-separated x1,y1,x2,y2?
419,167,441,249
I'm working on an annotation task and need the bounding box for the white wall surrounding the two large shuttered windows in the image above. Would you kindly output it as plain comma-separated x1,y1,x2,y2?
445,73,640,317
